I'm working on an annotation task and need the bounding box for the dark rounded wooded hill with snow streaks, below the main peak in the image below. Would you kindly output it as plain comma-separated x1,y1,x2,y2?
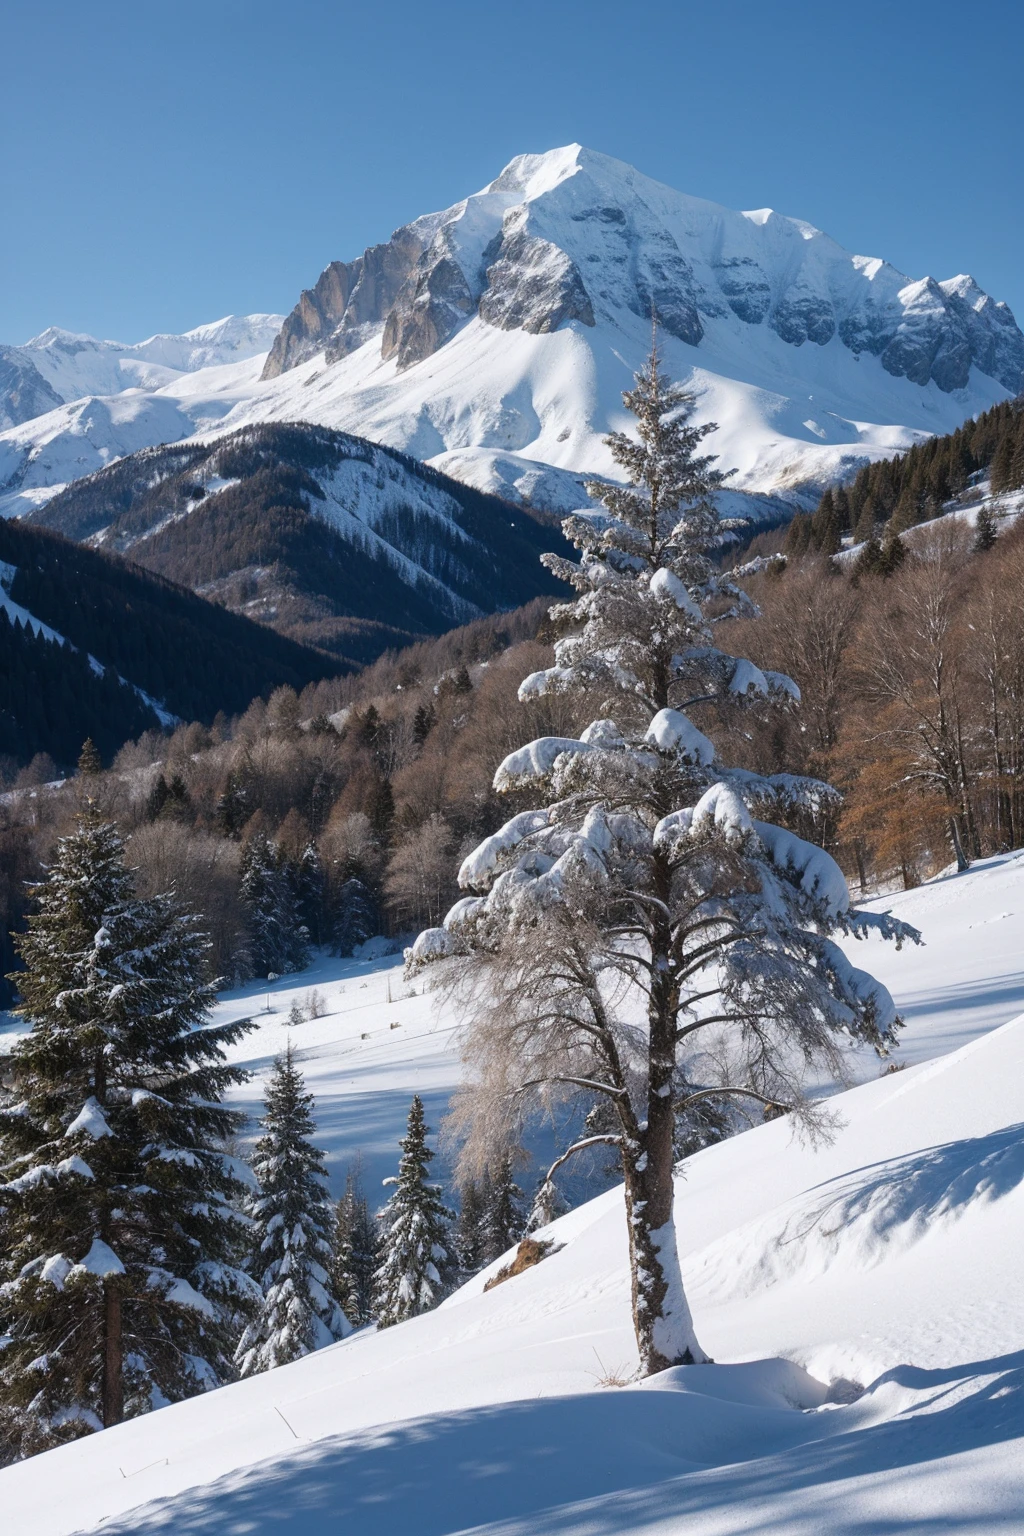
35,422,574,660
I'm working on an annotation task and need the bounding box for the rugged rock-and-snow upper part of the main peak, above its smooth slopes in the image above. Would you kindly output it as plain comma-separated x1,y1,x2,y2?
257,146,1024,393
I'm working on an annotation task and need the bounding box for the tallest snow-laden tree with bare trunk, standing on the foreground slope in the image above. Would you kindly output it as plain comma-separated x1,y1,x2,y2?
408,333,912,1373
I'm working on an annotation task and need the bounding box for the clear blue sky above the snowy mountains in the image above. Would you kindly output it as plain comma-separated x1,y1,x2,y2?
0,0,1024,341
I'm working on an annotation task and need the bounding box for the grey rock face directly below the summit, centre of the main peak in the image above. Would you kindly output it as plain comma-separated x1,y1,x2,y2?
481,229,594,335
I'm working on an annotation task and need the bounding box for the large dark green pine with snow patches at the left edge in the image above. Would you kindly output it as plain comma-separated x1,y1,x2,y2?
0,814,256,1459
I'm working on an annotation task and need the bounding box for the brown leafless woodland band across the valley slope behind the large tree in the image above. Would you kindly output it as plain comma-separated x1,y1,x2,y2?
3,479,1024,1013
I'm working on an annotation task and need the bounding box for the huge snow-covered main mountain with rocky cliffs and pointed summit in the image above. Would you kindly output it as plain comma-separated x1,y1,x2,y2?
0,144,1024,513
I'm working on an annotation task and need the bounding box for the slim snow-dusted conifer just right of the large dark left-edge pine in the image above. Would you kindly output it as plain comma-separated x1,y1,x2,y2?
235,1046,352,1376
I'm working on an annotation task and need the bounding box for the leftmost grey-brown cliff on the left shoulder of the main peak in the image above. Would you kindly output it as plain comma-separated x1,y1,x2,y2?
263,224,428,379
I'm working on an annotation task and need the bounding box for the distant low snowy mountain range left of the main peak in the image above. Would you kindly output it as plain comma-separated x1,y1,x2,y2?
0,315,282,427
